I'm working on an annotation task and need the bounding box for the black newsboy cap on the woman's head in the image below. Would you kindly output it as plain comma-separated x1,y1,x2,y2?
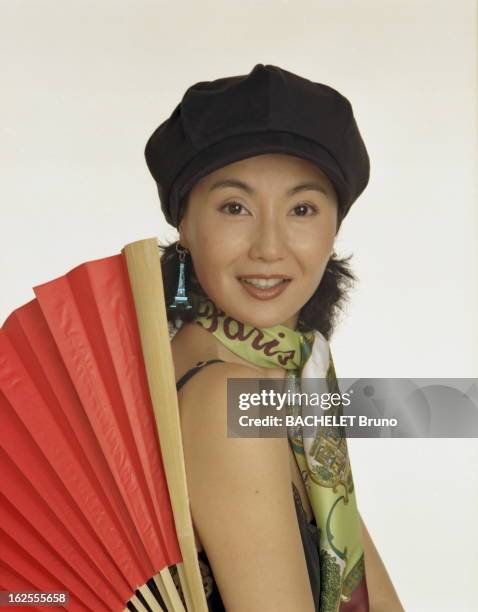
145,64,370,227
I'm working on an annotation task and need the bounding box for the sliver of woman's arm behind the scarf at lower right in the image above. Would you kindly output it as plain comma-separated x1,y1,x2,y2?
360,517,404,612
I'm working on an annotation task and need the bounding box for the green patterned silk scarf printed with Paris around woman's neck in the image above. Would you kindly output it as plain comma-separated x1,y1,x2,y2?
195,299,365,612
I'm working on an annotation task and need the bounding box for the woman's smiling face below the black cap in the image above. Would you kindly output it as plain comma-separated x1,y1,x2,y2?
179,153,337,329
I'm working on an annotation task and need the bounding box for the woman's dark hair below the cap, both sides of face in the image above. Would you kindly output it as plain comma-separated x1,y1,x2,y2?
159,202,357,340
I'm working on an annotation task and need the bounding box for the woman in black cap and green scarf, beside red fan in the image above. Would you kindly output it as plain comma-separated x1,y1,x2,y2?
145,64,402,612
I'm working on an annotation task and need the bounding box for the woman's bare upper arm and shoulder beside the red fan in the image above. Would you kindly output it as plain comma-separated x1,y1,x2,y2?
179,364,315,612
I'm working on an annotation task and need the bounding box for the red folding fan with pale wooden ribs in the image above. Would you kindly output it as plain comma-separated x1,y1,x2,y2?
0,238,207,612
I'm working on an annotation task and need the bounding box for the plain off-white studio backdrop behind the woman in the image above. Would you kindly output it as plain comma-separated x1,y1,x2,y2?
0,0,478,612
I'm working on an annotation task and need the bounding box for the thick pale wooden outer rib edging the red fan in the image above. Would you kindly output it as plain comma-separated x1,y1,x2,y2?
123,238,208,612
